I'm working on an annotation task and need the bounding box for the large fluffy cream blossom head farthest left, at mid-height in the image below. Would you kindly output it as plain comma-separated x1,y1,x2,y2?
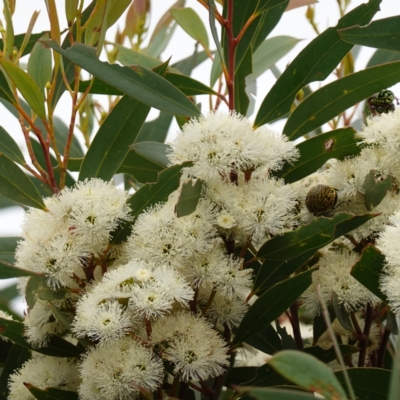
15,179,131,289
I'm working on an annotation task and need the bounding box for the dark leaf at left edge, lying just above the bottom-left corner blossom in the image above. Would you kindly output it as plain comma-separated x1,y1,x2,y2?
0,318,82,357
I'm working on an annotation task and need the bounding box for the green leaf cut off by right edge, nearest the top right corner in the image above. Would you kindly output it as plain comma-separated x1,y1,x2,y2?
338,16,400,51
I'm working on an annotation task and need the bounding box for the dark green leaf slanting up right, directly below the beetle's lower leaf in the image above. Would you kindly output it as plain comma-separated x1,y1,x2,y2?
234,269,313,344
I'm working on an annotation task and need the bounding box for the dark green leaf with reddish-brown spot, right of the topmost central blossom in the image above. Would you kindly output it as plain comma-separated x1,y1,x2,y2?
275,128,361,183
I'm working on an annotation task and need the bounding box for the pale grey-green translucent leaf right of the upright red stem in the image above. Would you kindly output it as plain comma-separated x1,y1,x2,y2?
249,36,300,80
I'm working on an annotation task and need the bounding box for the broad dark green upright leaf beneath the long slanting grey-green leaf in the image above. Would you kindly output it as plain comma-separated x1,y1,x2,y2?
79,96,150,181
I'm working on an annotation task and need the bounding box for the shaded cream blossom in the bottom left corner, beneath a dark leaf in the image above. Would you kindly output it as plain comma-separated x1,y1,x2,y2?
8,353,80,400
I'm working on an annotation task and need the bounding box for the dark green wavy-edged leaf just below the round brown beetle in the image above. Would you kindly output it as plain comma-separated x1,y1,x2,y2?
257,213,374,261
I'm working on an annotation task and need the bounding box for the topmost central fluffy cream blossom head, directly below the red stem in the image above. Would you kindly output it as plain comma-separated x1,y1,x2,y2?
168,112,298,180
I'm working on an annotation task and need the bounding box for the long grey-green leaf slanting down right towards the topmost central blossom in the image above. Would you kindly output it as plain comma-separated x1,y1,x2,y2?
45,40,200,117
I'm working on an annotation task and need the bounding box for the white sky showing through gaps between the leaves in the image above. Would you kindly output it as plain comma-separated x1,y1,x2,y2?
0,0,400,310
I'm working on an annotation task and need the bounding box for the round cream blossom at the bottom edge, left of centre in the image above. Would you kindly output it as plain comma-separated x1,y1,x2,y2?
78,337,163,400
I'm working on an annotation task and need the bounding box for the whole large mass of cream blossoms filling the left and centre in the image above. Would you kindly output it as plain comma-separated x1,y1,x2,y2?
9,113,297,400
